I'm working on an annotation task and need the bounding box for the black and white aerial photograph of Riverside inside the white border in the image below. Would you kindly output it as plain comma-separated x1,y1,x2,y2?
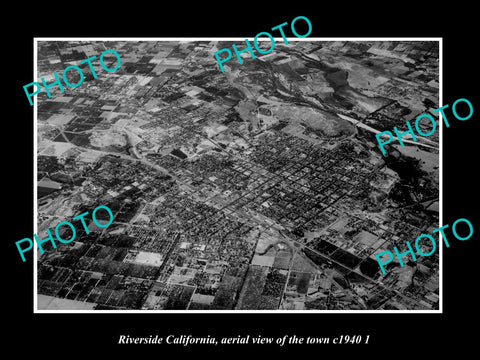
35,37,440,313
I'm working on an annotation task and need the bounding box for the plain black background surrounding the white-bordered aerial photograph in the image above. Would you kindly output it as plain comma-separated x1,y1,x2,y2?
2,1,480,358
